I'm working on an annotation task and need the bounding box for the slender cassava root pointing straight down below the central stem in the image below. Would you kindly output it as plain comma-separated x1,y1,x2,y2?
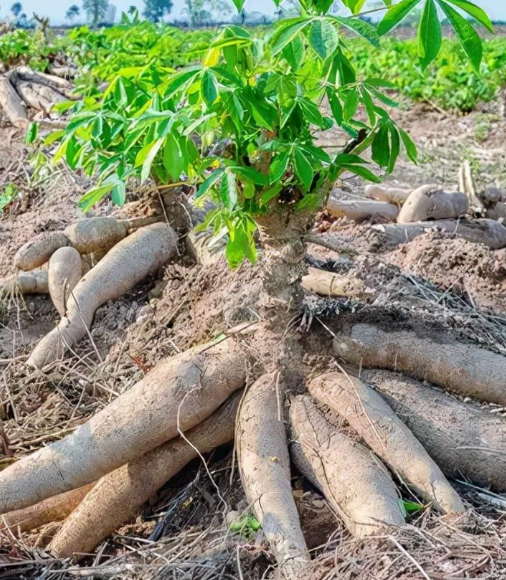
236,373,309,577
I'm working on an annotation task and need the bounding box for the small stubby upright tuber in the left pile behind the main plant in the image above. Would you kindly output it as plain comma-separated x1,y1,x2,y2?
48,248,82,316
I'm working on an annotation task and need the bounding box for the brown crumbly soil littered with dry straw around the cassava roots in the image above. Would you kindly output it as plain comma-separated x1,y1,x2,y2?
0,93,506,580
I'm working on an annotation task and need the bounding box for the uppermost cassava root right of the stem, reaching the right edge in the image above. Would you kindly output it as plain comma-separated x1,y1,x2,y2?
334,323,506,405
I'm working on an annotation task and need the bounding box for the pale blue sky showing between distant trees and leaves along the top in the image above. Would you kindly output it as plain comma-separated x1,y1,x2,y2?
0,0,506,24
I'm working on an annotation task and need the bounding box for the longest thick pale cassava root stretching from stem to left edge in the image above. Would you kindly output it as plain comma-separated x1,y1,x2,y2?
0,339,247,513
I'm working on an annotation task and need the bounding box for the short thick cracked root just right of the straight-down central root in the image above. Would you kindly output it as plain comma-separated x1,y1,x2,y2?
290,396,404,538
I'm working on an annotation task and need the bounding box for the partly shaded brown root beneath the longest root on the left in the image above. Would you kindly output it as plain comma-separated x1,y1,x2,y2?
49,392,242,559
